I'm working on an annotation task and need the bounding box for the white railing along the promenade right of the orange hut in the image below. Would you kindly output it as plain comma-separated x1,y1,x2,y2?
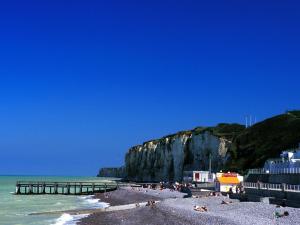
243,182,300,192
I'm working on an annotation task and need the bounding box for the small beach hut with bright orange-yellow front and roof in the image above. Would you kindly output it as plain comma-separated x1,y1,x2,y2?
215,172,243,193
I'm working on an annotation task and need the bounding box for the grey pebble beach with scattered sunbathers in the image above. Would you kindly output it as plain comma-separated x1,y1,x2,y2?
77,187,300,225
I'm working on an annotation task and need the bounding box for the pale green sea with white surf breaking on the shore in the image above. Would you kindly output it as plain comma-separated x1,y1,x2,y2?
0,176,108,225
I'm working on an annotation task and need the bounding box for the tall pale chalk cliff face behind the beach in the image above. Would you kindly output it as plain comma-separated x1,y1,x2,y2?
125,130,230,181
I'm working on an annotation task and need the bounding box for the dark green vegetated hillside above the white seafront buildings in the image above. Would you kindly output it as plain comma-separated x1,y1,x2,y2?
226,111,300,171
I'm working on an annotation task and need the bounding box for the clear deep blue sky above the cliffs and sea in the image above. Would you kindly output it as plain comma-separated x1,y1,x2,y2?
0,0,300,175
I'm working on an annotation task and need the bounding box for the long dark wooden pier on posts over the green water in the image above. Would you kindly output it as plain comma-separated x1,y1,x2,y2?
15,181,118,195
